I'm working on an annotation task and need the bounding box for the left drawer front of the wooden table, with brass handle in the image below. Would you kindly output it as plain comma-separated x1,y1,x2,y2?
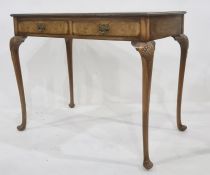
18,20,68,35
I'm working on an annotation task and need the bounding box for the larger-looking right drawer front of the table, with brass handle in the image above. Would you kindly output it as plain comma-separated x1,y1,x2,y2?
72,20,140,37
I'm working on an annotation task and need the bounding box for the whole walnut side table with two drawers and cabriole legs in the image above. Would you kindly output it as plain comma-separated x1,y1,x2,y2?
10,11,188,169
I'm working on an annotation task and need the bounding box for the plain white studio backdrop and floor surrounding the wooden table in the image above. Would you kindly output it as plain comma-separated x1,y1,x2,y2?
0,0,210,175
